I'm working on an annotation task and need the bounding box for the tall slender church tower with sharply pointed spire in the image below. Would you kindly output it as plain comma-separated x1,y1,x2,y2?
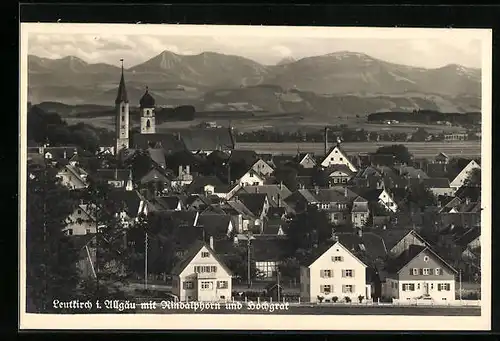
115,59,129,155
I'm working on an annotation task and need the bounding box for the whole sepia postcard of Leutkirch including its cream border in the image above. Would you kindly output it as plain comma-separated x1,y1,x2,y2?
19,23,492,331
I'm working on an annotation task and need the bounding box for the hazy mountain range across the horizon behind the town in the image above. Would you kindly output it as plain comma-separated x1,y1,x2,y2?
28,51,481,115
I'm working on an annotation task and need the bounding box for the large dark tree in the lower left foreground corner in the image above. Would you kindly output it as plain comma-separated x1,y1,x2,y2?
26,165,79,312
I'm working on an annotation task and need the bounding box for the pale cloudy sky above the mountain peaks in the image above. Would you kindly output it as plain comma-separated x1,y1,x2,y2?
28,33,481,68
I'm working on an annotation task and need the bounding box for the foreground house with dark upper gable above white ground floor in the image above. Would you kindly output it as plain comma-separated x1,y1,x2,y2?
382,245,457,304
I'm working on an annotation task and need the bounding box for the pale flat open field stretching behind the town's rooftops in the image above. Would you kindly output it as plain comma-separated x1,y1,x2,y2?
235,141,481,157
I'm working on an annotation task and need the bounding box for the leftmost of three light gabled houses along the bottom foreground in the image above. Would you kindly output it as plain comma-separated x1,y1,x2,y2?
172,239,232,302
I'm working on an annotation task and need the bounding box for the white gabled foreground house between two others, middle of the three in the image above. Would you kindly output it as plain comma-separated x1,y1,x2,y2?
300,241,371,302
